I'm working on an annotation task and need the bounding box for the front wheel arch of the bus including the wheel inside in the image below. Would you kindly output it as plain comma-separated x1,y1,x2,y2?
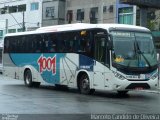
77,71,95,94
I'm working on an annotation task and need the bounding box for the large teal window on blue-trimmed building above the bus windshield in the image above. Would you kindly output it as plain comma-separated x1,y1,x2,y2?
118,7,133,25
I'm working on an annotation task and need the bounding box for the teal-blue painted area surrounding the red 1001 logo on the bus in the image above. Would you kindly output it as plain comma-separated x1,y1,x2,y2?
10,53,65,84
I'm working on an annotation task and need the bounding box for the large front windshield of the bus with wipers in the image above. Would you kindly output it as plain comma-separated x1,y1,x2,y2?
111,31,157,68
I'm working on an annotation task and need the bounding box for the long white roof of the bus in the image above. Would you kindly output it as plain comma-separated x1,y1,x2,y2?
6,23,150,36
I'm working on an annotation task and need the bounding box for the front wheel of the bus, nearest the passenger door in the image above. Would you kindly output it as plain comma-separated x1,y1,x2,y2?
79,74,95,94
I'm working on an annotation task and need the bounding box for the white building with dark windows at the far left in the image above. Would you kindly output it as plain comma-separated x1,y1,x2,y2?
0,0,42,33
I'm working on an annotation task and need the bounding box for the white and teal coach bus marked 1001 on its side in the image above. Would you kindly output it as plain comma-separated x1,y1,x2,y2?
3,23,158,94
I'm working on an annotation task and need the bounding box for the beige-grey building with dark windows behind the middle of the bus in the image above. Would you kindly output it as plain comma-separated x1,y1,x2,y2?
66,0,116,23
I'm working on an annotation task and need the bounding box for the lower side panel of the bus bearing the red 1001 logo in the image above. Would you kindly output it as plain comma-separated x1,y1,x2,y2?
4,53,94,87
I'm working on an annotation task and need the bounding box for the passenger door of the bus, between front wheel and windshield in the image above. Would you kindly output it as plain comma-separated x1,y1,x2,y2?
93,35,106,90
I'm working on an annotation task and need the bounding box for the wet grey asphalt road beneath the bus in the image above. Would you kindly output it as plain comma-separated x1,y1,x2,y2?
0,76,160,120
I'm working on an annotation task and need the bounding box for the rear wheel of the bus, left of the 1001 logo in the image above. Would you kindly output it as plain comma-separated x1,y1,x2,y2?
24,70,33,87
